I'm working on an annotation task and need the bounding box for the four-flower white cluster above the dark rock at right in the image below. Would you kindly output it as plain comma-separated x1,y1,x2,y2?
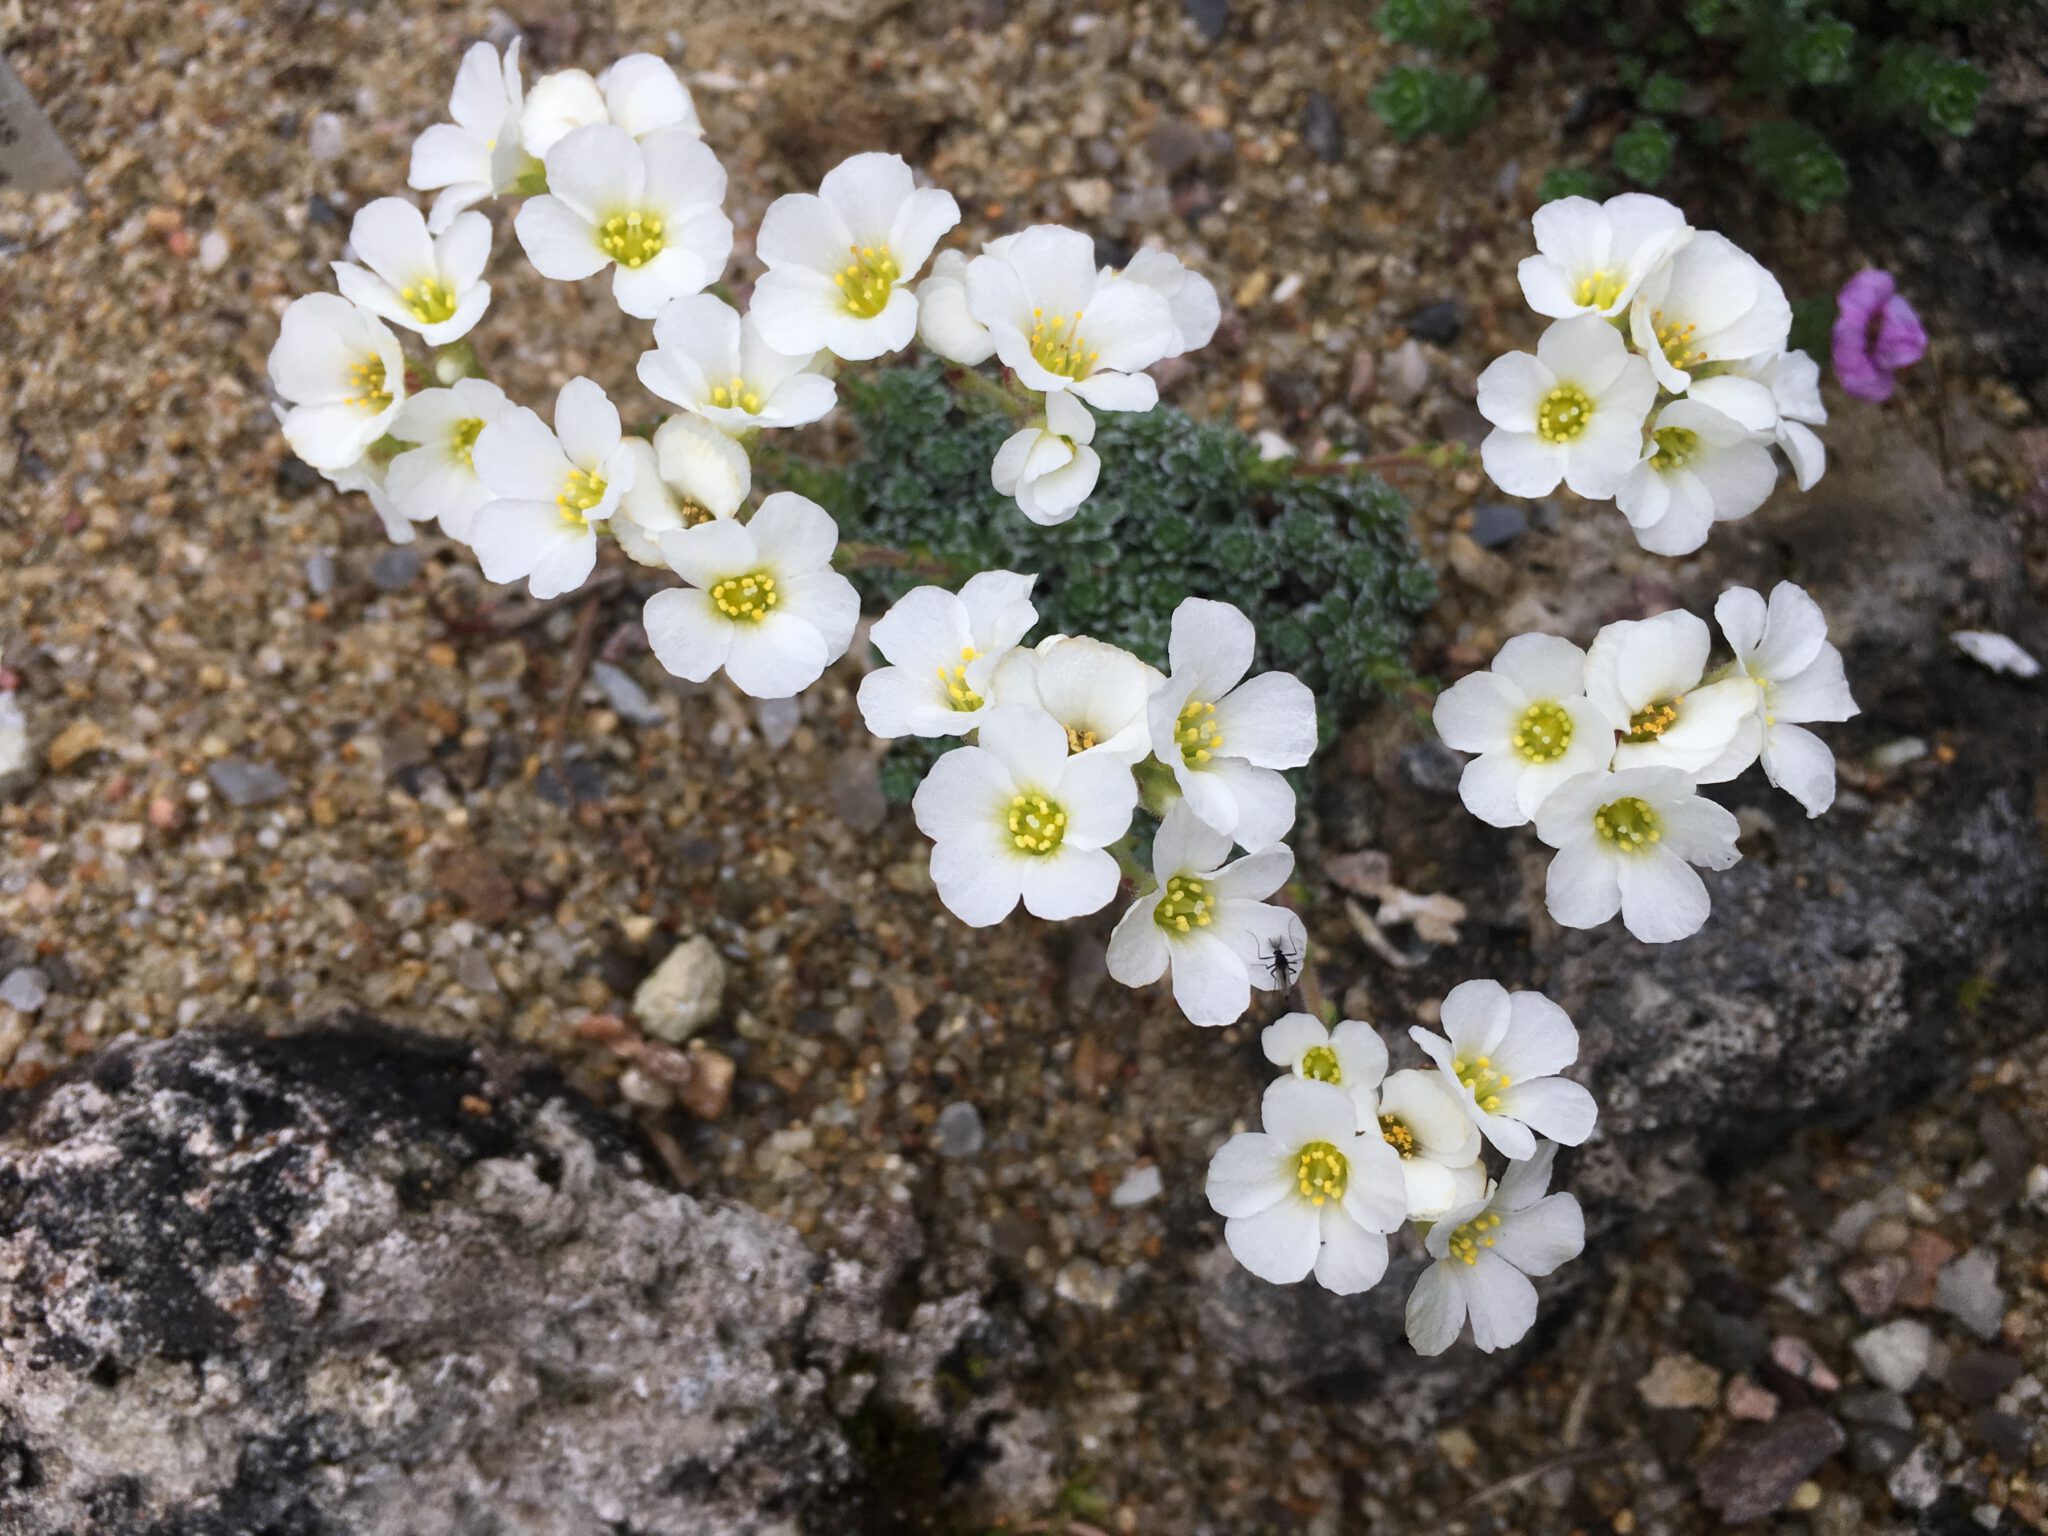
1436,582,1855,944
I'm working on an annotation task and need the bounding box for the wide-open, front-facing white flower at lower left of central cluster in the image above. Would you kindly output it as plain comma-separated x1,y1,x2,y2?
911,705,1137,928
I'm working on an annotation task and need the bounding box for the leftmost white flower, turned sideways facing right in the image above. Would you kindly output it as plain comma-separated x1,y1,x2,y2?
270,293,406,471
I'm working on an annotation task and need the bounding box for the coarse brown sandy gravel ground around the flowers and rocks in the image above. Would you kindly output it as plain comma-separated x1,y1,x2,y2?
0,0,2048,1536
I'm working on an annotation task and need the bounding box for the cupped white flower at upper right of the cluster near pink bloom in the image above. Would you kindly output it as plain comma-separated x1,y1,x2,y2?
1628,229,1792,395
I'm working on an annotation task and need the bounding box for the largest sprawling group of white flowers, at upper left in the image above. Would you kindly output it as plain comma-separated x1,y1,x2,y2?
270,43,1212,700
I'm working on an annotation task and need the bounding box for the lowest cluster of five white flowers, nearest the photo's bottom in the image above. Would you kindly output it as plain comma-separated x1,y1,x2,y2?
1208,981,1597,1354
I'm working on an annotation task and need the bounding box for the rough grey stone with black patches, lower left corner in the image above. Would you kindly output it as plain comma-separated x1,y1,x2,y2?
0,1022,937,1536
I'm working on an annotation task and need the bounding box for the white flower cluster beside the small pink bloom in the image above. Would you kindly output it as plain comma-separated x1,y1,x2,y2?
1479,193,1827,555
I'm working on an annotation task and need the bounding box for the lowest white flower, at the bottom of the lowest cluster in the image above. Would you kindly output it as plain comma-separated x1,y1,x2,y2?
1407,1145,1585,1354
